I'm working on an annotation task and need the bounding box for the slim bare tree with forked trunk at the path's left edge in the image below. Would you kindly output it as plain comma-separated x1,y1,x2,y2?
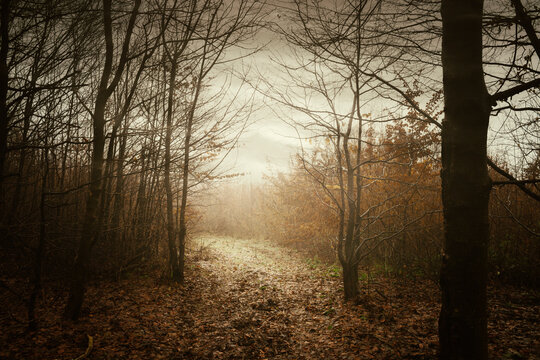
157,0,261,282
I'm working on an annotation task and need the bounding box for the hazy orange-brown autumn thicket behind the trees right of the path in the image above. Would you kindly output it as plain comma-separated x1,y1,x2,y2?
198,113,540,286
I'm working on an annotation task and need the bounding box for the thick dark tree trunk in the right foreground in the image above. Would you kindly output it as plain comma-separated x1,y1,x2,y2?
439,0,490,360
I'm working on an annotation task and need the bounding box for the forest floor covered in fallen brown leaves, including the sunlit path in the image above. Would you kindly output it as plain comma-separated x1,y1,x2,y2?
0,237,540,359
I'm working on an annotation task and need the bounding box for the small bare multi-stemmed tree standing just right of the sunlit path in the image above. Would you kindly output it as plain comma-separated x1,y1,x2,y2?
270,1,434,299
